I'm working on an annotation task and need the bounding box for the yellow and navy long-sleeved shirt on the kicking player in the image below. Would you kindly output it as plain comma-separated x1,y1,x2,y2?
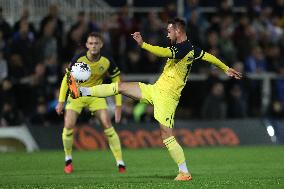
142,40,229,100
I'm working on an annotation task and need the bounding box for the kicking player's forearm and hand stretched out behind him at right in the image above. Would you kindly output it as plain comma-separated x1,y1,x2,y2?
202,52,242,79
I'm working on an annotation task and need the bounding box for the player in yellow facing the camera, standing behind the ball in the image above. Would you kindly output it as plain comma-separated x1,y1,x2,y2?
56,33,126,173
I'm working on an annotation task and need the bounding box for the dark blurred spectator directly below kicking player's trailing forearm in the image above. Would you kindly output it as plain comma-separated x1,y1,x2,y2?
201,83,227,120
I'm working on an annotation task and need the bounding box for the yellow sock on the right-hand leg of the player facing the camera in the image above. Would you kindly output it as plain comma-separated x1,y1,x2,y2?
104,127,122,161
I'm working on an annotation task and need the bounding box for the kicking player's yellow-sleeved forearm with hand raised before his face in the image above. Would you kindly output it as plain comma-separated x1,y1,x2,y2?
131,32,173,58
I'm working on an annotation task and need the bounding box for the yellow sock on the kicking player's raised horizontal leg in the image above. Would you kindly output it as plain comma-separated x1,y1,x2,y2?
91,83,118,97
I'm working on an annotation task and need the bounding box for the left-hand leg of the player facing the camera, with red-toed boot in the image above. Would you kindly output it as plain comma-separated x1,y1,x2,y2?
62,110,78,174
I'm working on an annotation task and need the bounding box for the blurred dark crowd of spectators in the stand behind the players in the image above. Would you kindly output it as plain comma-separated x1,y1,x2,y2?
0,0,284,126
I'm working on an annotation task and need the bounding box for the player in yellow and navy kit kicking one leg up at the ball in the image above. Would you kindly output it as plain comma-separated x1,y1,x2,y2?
70,18,241,180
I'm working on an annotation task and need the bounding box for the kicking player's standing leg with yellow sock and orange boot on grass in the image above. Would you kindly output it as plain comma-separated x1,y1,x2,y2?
160,124,192,181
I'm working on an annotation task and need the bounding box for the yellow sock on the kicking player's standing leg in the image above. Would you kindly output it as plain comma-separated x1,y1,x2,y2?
163,136,185,165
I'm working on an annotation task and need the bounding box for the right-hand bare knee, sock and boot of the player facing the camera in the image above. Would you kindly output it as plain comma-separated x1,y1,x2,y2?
96,109,126,173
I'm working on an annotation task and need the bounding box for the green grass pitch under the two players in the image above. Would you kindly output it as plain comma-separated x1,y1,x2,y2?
0,146,284,189
